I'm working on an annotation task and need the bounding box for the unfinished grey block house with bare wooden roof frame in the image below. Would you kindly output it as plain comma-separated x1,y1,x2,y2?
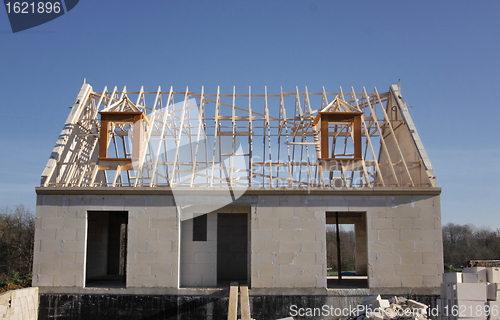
33,84,443,318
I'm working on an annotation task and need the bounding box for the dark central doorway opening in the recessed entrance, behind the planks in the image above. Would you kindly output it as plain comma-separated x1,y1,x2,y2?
217,213,250,286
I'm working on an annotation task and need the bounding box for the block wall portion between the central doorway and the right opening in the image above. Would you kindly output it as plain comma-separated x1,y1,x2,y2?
251,195,326,288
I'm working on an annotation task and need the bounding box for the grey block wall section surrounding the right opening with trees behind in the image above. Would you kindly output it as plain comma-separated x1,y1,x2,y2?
251,195,443,294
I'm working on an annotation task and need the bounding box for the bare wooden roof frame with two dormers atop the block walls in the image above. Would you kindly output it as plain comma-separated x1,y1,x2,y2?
41,84,436,188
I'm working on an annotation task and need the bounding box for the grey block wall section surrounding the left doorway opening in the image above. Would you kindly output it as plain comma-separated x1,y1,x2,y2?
32,195,179,287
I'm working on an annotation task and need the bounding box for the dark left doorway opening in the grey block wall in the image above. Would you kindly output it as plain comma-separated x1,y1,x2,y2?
85,211,128,288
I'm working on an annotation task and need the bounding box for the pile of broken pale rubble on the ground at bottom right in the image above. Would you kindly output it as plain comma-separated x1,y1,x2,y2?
349,295,428,320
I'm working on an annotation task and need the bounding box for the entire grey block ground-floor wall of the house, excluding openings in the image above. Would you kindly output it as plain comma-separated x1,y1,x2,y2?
33,191,443,294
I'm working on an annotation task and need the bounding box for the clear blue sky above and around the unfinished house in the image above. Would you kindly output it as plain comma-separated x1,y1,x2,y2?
0,0,500,229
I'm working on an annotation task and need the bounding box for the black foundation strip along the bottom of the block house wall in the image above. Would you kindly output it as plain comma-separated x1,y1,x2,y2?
38,294,439,320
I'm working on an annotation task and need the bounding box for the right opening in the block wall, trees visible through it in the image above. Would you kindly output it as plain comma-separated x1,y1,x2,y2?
326,212,368,288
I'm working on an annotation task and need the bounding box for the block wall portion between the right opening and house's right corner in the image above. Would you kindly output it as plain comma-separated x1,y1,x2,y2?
364,196,443,294
